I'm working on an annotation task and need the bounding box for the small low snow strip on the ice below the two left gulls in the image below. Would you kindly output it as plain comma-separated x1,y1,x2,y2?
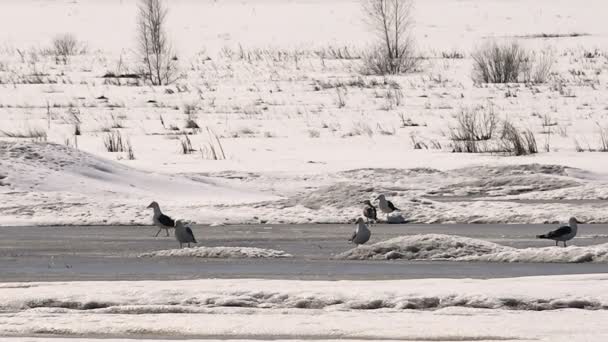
139,247,292,259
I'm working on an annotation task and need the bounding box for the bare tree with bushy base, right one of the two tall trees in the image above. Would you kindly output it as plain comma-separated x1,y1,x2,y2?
362,0,418,74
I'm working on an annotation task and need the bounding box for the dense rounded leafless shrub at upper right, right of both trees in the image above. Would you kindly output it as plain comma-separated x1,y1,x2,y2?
471,41,530,83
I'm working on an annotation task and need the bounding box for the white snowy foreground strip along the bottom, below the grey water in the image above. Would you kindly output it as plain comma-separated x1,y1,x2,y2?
0,275,608,341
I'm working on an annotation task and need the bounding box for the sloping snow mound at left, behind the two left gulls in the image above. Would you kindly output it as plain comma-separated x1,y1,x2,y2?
0,141,276,225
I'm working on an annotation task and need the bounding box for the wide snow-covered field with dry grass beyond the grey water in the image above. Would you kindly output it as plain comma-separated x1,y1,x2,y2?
0,0,608,225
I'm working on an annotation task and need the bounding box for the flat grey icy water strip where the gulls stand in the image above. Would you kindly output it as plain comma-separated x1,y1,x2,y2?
0,224,608,282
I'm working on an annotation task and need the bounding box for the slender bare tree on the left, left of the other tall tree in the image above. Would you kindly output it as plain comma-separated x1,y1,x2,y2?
137,0,177,85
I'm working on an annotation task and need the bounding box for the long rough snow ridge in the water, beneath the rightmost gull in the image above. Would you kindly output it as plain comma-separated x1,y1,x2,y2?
336,234,608,263
